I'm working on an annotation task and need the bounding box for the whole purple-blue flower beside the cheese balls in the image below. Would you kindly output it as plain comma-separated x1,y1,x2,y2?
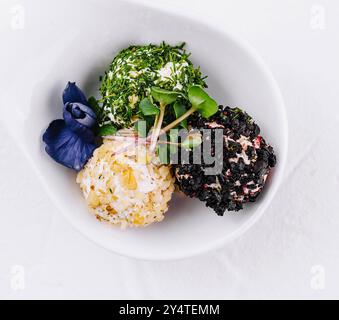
42,82,96,171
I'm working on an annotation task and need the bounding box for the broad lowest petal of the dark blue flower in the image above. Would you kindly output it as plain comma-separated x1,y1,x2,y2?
43,120,96,171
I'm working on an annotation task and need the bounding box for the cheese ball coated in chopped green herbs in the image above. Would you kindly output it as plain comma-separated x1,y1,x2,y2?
99,43,206,128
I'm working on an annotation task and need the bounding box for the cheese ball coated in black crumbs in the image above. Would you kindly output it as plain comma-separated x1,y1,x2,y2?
173,106,276,216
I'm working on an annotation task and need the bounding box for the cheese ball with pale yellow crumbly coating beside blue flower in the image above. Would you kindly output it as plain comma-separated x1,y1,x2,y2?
77,138,174,228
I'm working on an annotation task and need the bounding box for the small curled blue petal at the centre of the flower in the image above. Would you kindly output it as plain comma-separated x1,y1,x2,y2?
63,103,96,130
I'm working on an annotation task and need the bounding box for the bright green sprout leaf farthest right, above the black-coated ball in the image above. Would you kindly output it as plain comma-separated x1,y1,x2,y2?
188,86,218,119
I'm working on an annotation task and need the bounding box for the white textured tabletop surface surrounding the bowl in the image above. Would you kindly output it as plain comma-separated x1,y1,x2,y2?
0,0,339,299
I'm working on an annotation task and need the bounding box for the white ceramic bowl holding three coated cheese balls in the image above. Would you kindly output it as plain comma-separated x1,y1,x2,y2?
0,0,287,260
